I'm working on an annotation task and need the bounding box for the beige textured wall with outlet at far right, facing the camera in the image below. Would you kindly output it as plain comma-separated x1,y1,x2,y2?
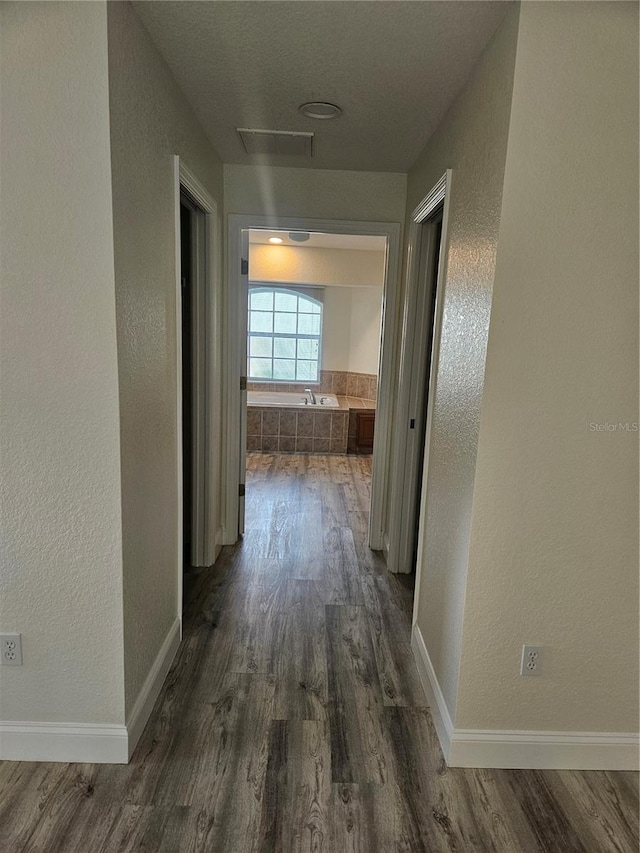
456,3,638,732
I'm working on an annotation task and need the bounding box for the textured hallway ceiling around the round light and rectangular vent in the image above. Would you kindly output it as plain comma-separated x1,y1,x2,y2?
133,0,510,172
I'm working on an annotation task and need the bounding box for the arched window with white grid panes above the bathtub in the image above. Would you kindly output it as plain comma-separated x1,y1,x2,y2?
247,286,322,382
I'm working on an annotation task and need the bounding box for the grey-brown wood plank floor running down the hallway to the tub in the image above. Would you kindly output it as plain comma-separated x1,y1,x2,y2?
0,455,638,853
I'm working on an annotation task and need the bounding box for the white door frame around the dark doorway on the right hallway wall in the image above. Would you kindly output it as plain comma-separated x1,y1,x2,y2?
387,169,452,572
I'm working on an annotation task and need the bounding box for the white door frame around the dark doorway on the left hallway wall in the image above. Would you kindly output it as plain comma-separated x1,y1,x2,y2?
173,154,219,630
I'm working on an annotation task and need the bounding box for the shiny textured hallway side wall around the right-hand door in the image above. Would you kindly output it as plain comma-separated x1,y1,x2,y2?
407,8,518,716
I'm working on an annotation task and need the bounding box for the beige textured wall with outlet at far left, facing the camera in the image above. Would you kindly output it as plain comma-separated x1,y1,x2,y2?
0,2,124,724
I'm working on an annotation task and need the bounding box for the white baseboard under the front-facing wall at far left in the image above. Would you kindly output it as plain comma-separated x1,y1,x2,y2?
0,722,129,764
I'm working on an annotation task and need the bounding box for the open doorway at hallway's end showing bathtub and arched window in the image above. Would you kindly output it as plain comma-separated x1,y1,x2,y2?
243,229,387,536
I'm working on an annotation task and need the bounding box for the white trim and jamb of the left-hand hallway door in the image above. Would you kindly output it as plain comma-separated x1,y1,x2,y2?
173,154,219,619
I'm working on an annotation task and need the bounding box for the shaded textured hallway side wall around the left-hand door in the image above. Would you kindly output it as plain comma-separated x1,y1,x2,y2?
108,3,228,713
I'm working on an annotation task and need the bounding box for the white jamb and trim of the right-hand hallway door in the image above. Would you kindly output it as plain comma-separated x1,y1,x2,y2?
387,169,453,572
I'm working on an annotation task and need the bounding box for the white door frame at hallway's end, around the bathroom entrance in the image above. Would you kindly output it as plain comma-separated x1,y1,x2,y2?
223,214,400,550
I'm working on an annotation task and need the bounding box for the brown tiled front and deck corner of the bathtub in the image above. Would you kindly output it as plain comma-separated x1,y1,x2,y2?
247,397,375,454
